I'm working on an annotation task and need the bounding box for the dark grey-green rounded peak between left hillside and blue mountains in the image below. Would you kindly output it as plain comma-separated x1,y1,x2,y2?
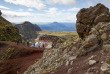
15,21,41,39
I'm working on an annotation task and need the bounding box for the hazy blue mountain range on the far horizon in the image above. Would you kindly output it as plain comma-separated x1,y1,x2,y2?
38,22,76,31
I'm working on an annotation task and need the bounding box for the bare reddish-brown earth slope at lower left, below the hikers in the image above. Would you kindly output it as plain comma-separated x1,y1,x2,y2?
0,41,45,74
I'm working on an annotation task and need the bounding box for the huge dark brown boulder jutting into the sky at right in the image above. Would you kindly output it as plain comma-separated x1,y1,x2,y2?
76,3,110,39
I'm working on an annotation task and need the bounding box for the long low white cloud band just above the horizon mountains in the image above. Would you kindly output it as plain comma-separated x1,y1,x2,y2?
2,7,76,22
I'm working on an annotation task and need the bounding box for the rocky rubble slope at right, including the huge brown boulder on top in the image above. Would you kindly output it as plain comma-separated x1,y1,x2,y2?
24,4,110,74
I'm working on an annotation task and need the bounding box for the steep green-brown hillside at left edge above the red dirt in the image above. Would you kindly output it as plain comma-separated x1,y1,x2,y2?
0,12,22,42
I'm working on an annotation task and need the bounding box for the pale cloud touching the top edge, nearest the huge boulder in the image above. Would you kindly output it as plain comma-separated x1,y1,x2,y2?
47,0,76,5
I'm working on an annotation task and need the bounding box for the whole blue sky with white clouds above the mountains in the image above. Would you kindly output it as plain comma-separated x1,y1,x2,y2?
0,0,110,23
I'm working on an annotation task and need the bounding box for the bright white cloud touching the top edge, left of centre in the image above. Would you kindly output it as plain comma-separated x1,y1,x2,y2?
5,0,46,10
